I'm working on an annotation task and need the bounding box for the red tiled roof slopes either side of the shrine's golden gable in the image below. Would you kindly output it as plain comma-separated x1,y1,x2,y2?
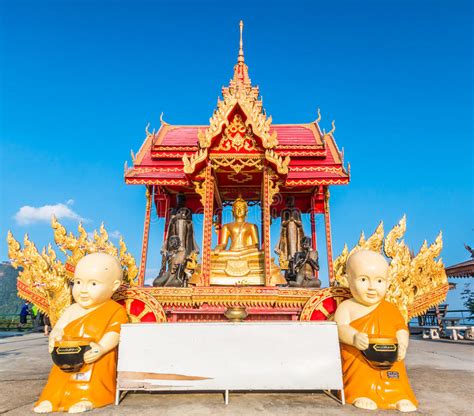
125,123,349,184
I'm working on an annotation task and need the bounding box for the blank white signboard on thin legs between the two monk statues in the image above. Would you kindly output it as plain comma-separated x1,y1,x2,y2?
116,322,343,404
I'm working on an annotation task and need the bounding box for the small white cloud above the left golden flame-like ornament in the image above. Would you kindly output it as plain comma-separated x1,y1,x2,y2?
14,199,87,225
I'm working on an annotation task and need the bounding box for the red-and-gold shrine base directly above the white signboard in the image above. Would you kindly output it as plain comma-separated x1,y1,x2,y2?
114,286,350,322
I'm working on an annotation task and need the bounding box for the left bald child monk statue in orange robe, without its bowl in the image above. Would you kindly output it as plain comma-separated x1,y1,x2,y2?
34,253,128,413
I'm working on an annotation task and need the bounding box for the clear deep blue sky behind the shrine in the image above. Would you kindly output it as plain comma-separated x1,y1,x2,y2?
0,0,474,306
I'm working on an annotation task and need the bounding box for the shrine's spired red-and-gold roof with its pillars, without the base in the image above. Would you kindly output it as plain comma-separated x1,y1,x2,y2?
125,22,350,287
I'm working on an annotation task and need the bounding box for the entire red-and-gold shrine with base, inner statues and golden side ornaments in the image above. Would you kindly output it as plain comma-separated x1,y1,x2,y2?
7,22,448,328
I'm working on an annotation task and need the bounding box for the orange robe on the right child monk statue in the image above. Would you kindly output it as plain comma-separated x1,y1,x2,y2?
341,300,418,409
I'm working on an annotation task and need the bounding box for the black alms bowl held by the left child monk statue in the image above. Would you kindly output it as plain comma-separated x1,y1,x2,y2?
51,338,91,373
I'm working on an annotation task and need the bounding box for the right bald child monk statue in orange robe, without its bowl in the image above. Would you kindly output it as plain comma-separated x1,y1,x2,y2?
335,250,417,412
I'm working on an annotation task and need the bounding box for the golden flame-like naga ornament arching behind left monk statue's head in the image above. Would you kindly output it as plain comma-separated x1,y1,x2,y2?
7,216,138,325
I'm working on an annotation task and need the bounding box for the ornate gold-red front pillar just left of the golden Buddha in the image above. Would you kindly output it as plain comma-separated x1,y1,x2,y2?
201,166,215,286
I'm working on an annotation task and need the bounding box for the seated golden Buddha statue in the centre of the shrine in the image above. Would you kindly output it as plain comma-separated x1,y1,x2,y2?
210,197,286,285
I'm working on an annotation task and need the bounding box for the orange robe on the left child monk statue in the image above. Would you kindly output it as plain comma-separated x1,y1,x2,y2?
36,300,128,412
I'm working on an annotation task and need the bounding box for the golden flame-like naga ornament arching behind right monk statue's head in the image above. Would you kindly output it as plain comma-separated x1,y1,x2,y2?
334,216,449,322
